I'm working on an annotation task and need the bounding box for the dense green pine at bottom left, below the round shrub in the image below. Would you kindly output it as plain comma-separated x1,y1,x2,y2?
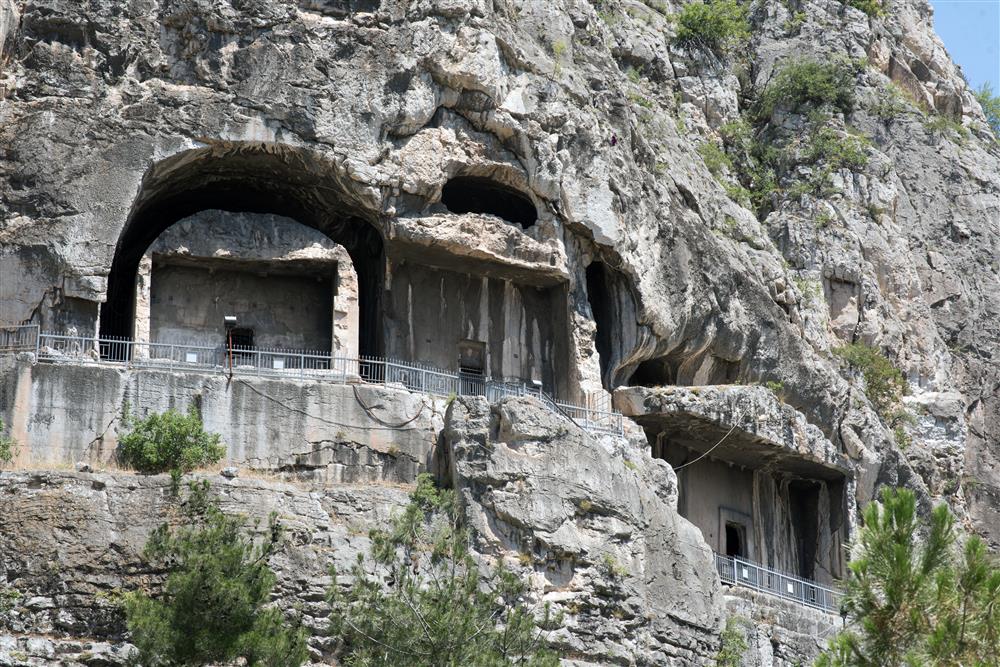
124,482,308,667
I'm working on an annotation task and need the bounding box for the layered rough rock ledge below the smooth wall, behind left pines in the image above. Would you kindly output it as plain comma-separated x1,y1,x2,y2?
0,471,408,665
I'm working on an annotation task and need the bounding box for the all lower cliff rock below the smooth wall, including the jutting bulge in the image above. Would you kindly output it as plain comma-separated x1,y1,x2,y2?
0,399,836,665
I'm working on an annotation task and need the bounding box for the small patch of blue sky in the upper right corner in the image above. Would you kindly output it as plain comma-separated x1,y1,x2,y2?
931,0,1000,93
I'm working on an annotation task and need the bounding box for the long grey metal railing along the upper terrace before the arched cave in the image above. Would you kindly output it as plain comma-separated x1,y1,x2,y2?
15,327,623,435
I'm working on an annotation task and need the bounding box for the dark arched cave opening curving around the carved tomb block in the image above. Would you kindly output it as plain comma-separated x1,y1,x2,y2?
100,151,385,356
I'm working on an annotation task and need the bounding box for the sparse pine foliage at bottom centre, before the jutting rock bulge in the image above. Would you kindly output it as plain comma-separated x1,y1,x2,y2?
329,474,559,667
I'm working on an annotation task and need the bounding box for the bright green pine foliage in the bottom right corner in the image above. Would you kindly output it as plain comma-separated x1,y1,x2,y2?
816,489,1000,667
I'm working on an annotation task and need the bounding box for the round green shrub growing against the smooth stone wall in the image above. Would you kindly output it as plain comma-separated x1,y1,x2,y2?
118,405,226,481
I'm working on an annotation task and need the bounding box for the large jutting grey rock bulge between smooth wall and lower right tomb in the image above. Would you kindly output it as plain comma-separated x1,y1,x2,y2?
445,398,723,665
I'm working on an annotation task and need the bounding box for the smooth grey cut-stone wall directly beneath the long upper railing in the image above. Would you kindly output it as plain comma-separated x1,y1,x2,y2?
0,355,443,484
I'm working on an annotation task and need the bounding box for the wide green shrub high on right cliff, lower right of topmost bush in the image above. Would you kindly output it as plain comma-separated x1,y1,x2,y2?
756,60,857,120
